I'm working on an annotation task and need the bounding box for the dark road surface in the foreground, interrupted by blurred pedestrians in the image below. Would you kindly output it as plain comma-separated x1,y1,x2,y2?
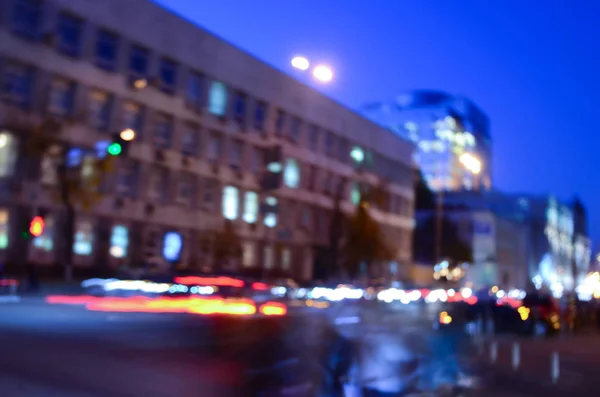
0,298,600,397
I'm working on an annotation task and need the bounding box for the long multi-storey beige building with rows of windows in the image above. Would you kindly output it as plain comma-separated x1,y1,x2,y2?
0,0,413,279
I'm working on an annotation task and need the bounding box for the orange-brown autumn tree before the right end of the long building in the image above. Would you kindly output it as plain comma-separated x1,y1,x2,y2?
344,186,395,277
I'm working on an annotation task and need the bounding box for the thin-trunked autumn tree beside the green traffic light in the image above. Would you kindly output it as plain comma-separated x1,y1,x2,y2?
25,117,113,280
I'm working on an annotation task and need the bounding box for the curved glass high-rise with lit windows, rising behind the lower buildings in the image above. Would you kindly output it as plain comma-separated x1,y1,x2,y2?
362,90,492,191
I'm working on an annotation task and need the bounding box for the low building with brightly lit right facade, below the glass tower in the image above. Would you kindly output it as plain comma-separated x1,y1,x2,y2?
444,192,591,293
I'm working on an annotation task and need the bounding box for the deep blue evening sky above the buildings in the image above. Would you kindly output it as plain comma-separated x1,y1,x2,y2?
159,0,600,241
